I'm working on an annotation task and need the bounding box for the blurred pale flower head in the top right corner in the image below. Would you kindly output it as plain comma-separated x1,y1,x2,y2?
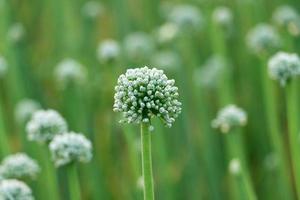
272,5,300,35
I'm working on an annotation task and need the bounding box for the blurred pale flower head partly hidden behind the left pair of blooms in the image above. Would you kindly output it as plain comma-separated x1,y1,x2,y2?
15,99,41,124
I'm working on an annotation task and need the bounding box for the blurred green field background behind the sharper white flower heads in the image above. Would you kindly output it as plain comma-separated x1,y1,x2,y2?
0,0,300,200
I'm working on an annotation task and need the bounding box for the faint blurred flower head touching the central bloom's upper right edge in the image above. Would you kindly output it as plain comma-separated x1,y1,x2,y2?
151,50,181,72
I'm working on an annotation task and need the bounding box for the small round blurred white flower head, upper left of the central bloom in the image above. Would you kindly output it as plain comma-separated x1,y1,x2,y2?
97,39,121,62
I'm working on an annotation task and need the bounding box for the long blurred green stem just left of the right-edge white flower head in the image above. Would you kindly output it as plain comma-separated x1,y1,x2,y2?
259,58,292,199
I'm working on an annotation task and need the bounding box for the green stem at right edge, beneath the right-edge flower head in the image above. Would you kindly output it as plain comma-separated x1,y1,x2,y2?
286,80,300,198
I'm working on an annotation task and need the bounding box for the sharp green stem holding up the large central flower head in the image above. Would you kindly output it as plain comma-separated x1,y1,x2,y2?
141,123,154,200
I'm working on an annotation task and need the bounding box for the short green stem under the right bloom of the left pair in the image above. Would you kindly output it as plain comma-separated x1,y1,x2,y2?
67,163,81,200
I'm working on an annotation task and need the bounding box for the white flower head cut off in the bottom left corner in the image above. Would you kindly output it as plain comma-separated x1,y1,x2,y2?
0,179,34,200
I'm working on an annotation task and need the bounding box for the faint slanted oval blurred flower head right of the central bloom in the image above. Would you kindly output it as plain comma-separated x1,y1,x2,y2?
194,55,228,89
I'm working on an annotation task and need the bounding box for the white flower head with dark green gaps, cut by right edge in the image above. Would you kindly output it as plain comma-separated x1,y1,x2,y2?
268,52,300,86
